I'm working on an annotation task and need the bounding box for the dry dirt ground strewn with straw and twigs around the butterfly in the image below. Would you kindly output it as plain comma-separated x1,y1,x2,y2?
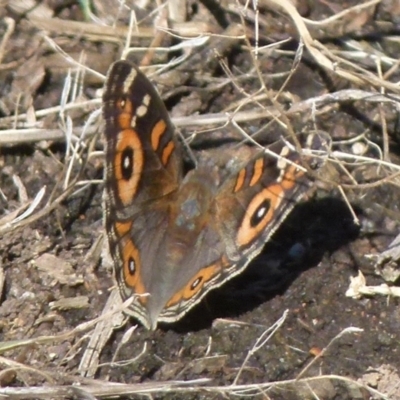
0,0,400,399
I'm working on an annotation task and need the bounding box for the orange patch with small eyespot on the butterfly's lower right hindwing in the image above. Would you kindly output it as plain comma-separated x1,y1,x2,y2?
166,260,224,308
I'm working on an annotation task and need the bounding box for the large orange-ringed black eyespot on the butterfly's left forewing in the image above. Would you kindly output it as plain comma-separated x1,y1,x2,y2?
114,128,144,206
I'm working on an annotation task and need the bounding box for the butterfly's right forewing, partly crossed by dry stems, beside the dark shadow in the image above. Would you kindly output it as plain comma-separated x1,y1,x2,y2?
216,134,322,264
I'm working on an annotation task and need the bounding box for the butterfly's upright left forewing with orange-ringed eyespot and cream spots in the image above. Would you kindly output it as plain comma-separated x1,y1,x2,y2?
103,61,182,208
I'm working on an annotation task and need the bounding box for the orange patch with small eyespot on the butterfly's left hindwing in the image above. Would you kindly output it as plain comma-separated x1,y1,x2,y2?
121,240,146,299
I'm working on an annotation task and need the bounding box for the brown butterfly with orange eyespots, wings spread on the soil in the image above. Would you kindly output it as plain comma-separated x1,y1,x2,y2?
103,61,321,329
